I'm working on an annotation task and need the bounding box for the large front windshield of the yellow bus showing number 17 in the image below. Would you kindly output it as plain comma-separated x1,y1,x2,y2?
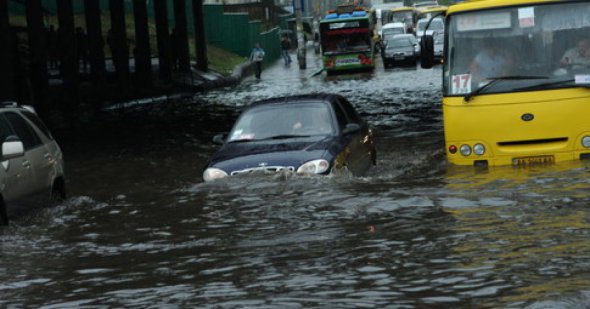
443,1,590,96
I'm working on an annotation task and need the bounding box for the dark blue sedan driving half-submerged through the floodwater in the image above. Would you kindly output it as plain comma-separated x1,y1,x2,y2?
203,94,376,181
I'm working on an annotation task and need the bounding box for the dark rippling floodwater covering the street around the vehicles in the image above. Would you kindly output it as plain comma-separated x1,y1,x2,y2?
0,52,590,308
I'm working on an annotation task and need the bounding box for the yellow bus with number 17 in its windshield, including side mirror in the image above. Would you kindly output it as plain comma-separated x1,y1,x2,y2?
421,0,590,166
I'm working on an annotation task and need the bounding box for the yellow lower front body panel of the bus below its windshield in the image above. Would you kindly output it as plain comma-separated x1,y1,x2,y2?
443,88,590,165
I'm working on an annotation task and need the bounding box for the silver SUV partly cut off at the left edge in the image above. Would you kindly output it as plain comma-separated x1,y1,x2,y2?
0,102,66,225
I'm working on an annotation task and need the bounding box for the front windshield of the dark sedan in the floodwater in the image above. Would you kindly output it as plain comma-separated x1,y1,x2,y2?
229,102,335,142
